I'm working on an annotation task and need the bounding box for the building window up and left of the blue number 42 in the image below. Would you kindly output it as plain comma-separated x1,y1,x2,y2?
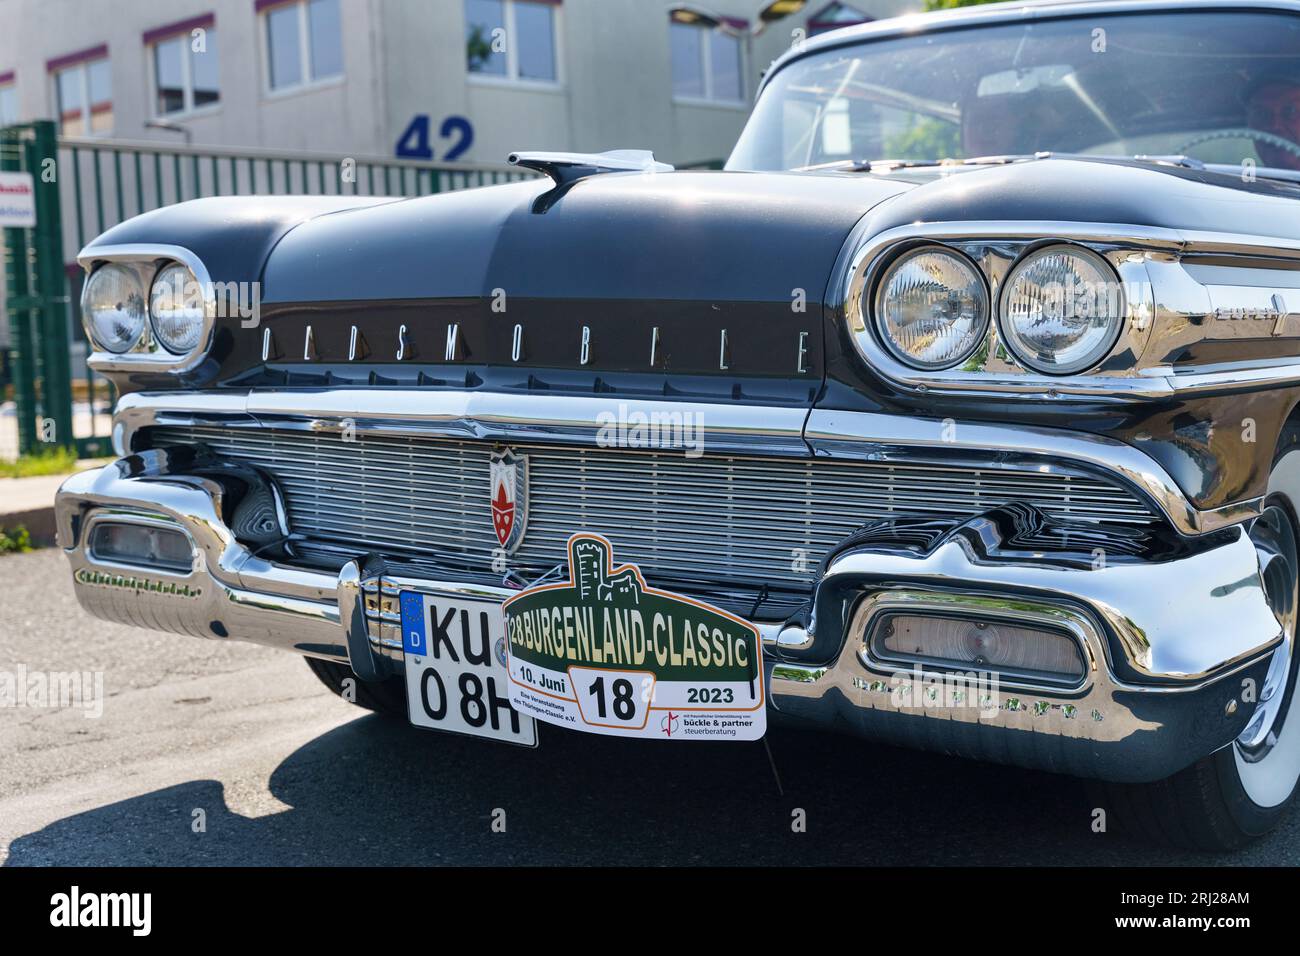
257,0,343,91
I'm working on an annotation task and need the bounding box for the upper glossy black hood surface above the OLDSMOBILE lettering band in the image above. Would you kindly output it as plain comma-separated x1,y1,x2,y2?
264,172,910,303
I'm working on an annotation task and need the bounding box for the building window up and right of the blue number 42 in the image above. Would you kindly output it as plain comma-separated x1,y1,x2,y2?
465,0,559,83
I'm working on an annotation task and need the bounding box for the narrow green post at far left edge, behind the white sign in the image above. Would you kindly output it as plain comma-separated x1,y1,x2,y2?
0,126,36,454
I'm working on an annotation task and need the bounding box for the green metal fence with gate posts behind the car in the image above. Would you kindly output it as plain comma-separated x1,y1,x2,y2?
0,121,533,463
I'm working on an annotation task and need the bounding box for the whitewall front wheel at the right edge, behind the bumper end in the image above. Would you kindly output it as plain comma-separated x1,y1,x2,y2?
1109,429,1300,851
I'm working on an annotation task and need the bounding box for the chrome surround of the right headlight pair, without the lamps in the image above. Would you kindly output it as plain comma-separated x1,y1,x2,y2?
827,219,1164,401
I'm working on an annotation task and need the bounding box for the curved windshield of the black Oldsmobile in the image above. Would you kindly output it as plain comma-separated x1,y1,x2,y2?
727,12,1300,169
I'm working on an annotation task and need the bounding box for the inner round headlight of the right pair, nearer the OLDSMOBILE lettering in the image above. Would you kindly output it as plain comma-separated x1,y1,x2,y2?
874,246,989,369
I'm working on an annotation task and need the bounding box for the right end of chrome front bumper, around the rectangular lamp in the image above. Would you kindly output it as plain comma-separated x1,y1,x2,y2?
770,518,1282,782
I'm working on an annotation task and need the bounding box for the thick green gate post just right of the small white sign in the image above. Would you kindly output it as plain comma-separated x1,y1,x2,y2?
26,120,77,447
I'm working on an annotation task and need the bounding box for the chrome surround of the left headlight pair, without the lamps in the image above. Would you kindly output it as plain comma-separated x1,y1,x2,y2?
77,243,217,373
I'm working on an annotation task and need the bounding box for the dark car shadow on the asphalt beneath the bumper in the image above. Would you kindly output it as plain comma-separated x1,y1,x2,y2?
8,715,1214,866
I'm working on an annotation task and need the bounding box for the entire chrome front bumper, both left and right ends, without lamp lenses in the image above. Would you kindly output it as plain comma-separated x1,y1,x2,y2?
56,444,1281,780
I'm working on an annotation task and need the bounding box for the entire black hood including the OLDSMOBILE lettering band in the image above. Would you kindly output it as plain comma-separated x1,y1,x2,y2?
233,172,911,405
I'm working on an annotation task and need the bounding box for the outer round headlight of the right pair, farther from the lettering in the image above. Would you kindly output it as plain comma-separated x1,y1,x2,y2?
1001,246,1125,375
